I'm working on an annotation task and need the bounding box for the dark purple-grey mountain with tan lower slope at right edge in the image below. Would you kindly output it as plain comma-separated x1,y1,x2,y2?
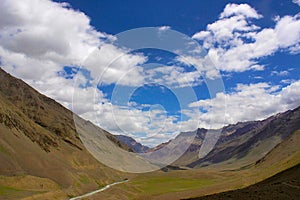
188,107,300,167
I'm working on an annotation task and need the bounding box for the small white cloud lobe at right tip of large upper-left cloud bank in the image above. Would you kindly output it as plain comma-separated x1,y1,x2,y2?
83,44,147,86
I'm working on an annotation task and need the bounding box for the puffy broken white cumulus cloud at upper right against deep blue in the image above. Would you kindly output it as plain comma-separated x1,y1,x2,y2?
193,4,300,72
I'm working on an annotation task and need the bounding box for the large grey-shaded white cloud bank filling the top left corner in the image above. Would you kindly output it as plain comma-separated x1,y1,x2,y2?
0,0,146,88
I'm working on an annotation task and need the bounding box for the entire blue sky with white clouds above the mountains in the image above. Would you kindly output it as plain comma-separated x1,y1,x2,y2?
0,0,300,146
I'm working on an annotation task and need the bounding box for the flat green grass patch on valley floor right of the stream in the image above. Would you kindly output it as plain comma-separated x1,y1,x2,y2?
131,177,214,195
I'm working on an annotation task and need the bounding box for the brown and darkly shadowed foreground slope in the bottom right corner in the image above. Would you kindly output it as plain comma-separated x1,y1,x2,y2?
185,131,300,200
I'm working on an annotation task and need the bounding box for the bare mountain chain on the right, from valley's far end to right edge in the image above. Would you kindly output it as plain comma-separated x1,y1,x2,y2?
149,107,300,168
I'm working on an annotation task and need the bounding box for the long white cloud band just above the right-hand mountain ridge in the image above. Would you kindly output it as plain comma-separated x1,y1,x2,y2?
190,81,300,128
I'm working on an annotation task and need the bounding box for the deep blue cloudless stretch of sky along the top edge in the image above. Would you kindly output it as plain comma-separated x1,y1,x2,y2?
54,0,299,36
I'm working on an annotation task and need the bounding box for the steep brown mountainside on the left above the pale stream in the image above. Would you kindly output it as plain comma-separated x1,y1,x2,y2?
0,69,133,199
